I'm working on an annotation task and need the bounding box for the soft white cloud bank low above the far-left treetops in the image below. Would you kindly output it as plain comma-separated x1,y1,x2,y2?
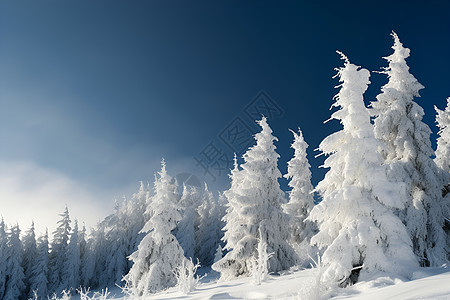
0,161,113,234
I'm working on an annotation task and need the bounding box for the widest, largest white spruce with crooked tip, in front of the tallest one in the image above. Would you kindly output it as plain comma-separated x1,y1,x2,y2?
309,54,417,286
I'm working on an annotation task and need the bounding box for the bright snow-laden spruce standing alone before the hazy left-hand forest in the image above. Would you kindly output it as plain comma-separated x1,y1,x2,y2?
124,160,189,295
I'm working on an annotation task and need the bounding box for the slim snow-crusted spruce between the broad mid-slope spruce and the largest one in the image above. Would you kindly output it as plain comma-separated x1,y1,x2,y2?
283,128,315,251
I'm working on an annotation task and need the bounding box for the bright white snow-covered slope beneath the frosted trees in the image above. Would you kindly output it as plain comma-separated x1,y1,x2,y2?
89,267,450,300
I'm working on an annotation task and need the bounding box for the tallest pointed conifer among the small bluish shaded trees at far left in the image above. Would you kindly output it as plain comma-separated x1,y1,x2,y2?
48,206,71,294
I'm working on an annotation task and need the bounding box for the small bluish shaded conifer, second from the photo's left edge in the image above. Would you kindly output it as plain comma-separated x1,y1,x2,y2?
2,224,25,300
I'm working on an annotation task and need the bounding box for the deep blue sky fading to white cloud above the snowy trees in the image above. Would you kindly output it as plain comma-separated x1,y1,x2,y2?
0,0,450,233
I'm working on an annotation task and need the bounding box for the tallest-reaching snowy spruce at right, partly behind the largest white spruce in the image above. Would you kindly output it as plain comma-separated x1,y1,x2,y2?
372,33,448,266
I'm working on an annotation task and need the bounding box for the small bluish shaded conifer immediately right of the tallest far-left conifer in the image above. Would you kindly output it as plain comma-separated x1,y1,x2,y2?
60,220,81,292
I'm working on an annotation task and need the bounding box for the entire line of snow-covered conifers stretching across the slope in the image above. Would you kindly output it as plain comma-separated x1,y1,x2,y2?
0,33,450,300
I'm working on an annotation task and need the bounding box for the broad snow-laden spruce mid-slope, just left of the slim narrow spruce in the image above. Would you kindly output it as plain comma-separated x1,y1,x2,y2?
212,117,298,280
